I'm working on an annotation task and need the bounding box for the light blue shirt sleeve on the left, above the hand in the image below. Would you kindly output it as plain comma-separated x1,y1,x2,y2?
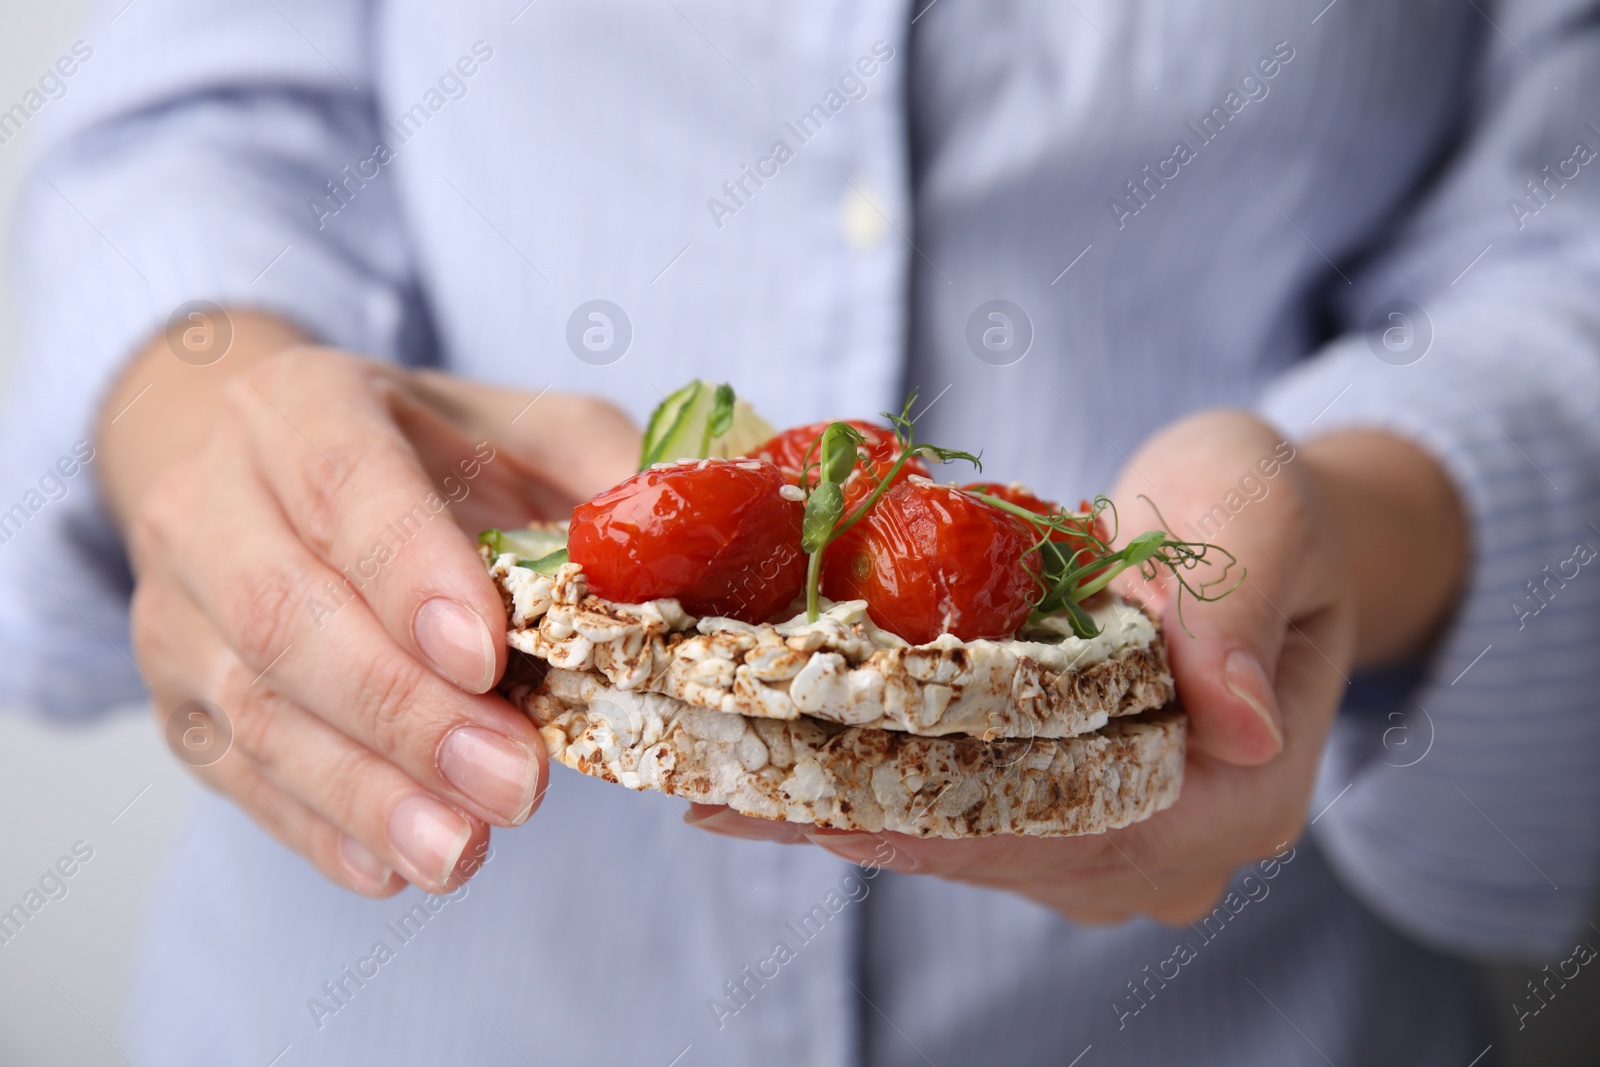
0,0,416,717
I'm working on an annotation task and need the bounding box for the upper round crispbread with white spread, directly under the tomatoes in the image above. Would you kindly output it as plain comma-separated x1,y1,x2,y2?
483,549,1174,741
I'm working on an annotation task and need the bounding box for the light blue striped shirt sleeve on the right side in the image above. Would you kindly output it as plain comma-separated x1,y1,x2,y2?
1262,3,1600,958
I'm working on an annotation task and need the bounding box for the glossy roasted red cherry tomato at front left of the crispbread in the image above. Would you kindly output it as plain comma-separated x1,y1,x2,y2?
566,459,806,622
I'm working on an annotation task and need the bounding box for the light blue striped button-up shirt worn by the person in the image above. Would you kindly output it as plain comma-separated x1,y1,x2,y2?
0,0,1600,1067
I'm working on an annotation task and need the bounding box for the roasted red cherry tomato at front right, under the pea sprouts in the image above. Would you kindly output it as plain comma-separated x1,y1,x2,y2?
822,478,1040,645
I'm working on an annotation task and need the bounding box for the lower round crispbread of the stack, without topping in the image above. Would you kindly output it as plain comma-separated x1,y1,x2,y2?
510,667,1186,838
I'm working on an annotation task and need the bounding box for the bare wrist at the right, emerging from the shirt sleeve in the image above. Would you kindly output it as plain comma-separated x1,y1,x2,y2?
1301,430,1469,667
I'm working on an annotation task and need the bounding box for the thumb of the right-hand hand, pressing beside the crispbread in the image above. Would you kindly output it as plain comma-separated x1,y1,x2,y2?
1114,411,1354,766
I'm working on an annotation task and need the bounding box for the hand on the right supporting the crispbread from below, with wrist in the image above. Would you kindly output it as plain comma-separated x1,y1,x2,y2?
686,411,1467,923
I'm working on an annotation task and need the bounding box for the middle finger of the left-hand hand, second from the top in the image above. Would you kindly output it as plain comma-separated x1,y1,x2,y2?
152,447,547,825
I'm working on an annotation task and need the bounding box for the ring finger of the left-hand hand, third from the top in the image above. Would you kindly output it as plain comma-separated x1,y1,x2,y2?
138,584,488,893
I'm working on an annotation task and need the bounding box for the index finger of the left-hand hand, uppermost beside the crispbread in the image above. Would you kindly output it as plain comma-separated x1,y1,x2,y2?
229,349,506,693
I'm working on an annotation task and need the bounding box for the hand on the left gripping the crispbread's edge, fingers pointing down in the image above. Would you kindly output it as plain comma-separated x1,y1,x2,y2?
96,310,638,896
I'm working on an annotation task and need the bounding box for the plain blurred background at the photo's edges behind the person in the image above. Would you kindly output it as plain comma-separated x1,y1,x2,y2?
0,0,1600,1067
